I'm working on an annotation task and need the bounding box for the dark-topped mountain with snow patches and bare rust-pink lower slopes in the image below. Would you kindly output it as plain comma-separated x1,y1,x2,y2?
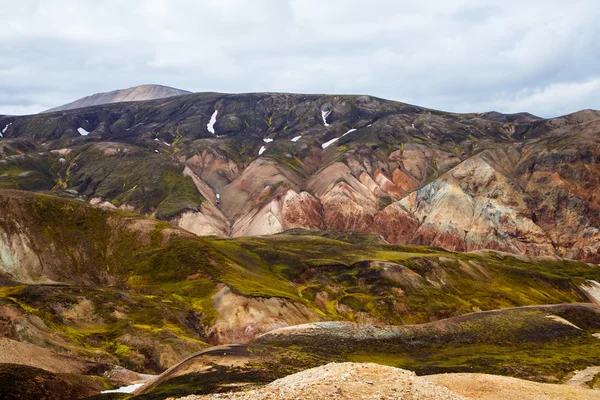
0,93,600,262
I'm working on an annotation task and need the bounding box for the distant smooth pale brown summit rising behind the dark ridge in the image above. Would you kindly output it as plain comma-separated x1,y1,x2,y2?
42,85,191,113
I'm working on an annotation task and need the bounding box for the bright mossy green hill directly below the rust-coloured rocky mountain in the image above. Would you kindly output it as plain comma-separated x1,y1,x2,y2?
0,191,600,390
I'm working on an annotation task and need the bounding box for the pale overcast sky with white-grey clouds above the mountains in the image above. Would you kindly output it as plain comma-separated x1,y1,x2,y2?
0,0,600,117
